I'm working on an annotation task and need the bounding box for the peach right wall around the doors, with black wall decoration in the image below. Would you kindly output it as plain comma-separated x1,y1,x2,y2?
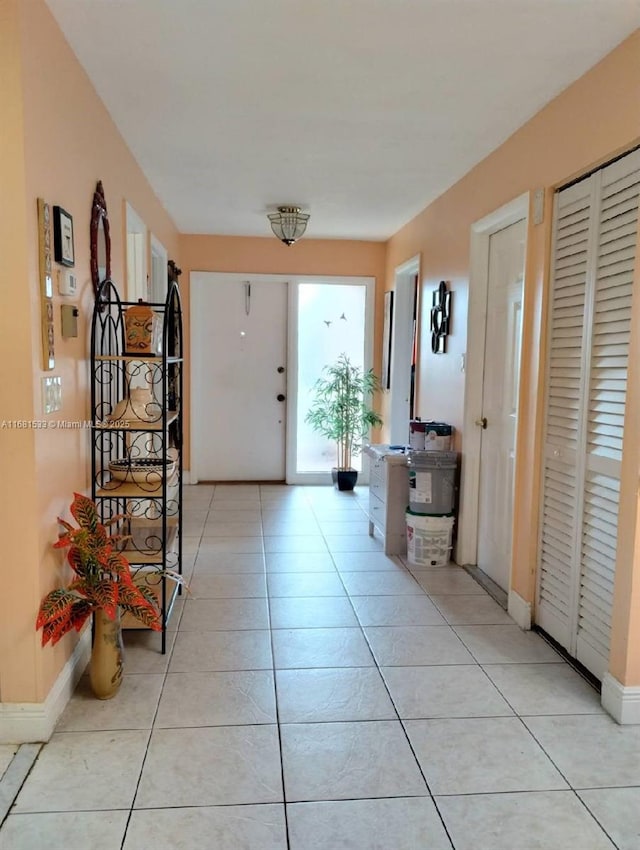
386,31,640,684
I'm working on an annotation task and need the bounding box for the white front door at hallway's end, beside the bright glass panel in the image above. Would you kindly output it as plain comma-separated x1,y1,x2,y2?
191,272,288,481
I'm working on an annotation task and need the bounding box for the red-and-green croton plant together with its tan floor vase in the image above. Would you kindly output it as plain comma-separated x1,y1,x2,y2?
36,493,183,699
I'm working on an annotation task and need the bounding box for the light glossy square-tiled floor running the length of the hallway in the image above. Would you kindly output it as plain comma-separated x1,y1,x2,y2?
0,485,640,850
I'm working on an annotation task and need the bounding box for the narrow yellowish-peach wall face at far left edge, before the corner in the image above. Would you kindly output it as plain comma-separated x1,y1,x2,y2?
0,0,38,701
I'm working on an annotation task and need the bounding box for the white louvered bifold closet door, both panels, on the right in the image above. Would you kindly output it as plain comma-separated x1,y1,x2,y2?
536,144,640,679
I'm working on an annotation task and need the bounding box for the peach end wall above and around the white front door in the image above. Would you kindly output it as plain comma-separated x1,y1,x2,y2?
180,235,386,468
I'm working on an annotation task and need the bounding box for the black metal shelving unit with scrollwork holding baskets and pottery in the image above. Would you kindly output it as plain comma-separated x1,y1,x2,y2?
91,280,183,654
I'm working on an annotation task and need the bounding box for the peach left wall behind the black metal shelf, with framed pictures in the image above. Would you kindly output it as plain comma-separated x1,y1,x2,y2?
0,0,179,703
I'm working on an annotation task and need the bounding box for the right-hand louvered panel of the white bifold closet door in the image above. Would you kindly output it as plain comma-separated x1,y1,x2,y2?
576,151,640,678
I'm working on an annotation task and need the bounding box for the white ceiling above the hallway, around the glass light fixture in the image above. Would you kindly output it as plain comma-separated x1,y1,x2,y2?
47,0,640,240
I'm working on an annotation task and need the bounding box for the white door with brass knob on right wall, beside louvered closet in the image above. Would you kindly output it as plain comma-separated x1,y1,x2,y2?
477,220,526,591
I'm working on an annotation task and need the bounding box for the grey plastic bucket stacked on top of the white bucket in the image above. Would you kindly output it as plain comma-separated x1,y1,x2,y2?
408,451,458,516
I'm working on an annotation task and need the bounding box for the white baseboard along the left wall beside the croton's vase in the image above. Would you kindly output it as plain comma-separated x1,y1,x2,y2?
0,628,91,744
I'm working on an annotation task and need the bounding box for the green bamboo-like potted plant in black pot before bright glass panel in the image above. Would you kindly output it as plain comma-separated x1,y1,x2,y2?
305,353,382,490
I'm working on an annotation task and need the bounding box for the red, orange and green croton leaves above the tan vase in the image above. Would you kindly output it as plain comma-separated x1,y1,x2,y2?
36,493,170,646
